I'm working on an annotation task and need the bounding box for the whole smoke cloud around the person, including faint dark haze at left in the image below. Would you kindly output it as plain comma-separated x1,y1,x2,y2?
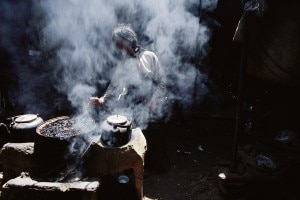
1,0,217,128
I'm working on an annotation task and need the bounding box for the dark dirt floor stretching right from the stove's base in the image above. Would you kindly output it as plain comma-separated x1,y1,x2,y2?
144,111,300,200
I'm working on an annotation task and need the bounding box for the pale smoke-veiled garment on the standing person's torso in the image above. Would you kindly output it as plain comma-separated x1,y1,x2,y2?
104,50,167,124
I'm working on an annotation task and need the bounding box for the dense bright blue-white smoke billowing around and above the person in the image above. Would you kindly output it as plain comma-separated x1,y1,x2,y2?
39,0,217,126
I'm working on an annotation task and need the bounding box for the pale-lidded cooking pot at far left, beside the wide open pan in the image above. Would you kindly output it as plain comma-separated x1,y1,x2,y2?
9,114,44,142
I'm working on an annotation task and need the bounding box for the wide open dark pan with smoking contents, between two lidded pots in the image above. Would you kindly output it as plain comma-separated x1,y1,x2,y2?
34,116,88,181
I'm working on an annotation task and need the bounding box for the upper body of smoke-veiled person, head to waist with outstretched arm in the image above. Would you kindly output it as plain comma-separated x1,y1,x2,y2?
91,24,168,126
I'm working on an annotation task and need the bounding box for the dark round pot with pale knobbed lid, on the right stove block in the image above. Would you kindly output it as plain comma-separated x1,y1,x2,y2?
101,115,132,147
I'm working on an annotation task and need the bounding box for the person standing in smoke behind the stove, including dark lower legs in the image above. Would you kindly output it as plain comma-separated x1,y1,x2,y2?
91,24,169,170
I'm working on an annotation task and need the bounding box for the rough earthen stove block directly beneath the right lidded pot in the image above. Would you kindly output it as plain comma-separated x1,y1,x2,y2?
85,128,147,199
